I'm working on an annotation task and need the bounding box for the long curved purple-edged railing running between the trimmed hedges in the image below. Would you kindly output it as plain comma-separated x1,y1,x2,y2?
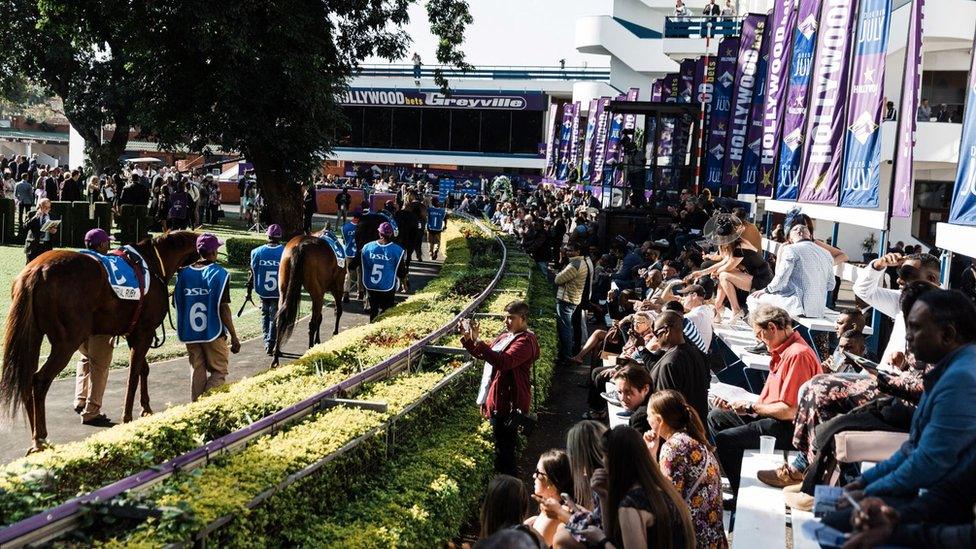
0,212,508,547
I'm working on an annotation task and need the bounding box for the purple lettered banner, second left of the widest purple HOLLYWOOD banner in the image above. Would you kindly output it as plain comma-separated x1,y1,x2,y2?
756,0,796,196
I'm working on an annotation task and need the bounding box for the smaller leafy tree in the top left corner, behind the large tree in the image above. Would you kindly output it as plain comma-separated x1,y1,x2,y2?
0,0,138,172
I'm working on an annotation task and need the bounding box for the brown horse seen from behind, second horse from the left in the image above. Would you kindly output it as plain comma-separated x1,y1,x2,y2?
272,232,348,365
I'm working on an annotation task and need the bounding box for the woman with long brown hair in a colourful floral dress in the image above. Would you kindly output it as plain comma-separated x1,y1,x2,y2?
644,390,729,549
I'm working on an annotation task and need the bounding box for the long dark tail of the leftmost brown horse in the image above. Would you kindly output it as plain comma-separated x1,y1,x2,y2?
0,272,43,418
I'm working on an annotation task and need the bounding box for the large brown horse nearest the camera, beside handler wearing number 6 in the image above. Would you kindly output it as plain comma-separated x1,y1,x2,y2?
0,231,198,453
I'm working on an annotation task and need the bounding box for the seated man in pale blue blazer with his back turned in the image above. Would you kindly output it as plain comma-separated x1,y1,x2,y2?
748,225,834,318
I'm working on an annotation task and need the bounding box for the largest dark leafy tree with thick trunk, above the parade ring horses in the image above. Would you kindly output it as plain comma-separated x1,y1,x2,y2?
124,0,472,234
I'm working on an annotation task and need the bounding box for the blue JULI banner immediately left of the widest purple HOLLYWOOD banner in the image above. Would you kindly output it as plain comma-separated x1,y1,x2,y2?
775,0,821,200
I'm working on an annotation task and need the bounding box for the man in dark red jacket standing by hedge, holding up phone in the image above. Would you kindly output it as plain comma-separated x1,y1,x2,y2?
459,300,539,476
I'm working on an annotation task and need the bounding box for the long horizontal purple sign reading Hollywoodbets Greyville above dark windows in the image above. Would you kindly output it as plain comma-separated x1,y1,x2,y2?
339,89,546,111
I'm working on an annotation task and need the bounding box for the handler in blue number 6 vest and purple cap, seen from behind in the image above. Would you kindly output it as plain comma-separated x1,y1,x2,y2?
173,233,241,402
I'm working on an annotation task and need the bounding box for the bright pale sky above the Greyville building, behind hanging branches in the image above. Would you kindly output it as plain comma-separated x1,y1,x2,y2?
366,0,610,67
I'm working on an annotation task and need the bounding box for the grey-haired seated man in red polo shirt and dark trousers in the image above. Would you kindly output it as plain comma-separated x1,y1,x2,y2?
708,304,821,495
